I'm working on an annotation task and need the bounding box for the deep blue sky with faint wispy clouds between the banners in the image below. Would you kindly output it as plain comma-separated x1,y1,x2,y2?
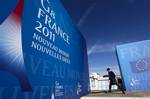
61,0,150,75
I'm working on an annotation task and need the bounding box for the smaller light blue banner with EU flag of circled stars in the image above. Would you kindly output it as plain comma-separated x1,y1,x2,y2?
117,40,150,91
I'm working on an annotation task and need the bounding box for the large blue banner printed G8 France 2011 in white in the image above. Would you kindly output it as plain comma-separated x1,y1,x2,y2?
0,0,90,99
